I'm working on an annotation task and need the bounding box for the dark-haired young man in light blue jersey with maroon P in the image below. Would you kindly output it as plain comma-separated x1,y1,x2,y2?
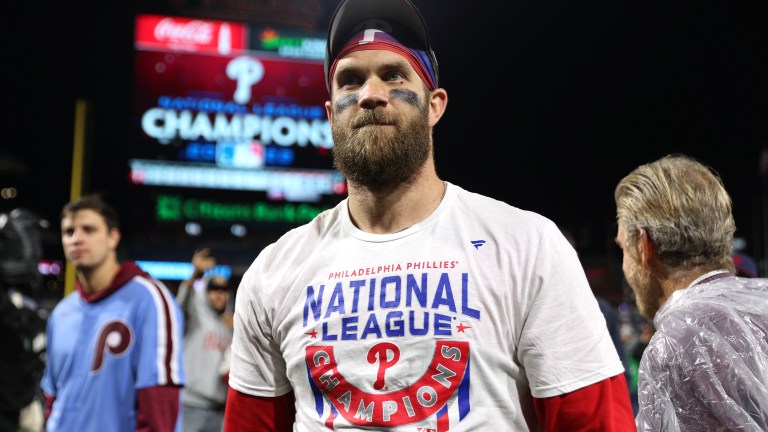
41,196,185,432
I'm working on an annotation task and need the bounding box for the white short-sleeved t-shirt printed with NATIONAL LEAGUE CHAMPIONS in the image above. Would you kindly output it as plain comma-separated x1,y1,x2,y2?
229,184,624,432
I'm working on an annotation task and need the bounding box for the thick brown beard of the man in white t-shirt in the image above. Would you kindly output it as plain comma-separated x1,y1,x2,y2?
331,99,431,187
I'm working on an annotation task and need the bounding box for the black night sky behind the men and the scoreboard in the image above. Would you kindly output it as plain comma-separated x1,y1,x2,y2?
7,0,768,270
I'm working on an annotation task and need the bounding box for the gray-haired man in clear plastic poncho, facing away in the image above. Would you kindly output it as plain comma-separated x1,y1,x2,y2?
615,155,768,432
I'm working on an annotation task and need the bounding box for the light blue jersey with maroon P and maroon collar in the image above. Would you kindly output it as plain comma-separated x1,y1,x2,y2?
41,262,185,432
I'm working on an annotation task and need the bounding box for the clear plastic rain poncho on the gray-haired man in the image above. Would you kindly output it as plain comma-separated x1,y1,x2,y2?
636,275,768,432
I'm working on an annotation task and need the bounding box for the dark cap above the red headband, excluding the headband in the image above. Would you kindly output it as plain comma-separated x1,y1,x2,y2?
325,0,438,91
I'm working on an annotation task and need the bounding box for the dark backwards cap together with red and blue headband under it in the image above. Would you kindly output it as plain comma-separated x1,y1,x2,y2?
325,0,438,92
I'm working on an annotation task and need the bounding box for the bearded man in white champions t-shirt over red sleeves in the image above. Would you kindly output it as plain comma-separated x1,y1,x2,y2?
224,0,635,432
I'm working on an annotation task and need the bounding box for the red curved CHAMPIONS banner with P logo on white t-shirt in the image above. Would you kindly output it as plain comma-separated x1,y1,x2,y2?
306,340,469,429
